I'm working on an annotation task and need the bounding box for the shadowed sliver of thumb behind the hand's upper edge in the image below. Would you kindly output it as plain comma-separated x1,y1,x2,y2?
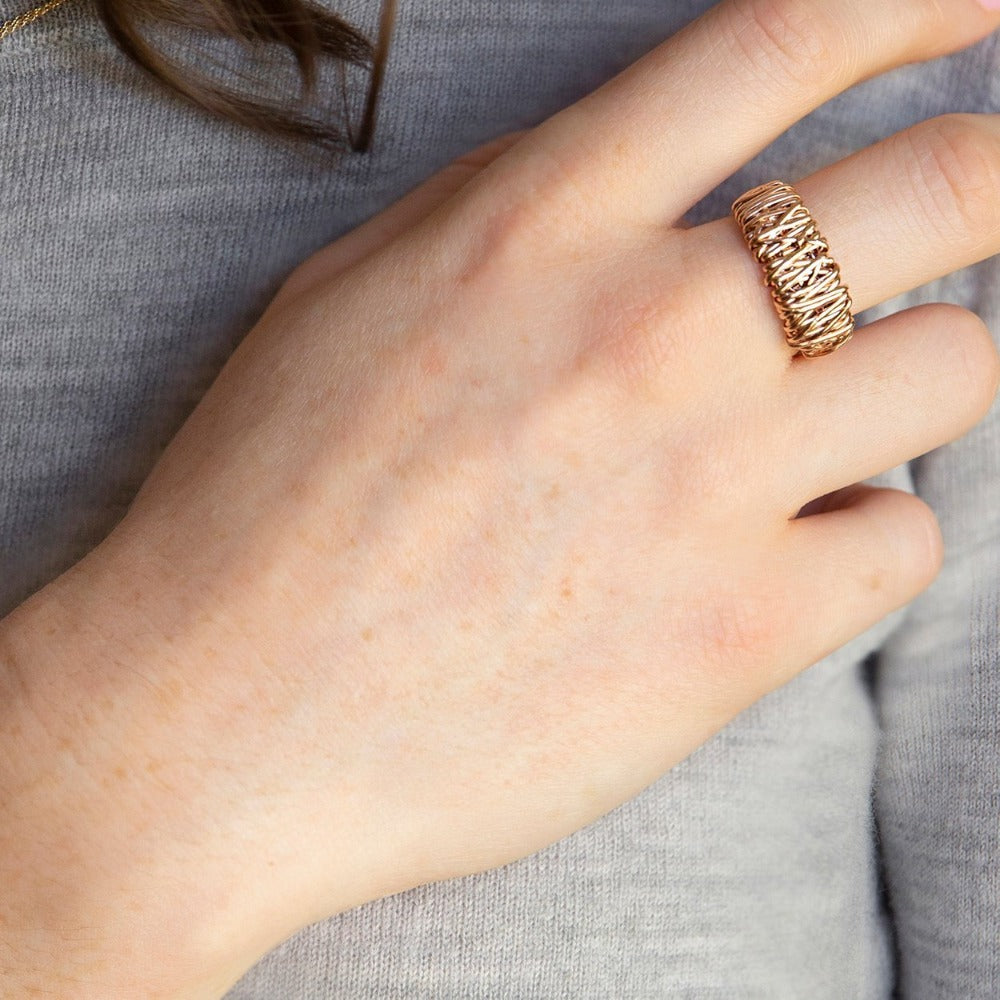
272,130,527,305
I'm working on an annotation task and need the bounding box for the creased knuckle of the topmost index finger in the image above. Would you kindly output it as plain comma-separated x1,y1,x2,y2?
729,0,849,96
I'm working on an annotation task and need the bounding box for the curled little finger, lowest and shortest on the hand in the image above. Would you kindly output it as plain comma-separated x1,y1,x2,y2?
775,484,943,681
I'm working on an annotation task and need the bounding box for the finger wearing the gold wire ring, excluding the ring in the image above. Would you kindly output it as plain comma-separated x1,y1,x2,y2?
685,114,1000,370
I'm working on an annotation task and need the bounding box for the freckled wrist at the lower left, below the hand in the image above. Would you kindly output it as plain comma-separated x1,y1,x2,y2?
0,559,284,1000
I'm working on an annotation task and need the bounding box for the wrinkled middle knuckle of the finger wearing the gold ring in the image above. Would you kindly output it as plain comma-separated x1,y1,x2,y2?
902,114,1000,247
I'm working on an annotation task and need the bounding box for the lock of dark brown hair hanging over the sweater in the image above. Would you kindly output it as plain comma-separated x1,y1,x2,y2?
96,0,396,152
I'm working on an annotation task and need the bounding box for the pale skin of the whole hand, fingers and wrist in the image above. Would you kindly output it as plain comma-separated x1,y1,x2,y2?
0,0,1000,1000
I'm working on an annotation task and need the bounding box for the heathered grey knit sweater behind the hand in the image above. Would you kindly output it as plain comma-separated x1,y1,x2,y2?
0,0,1000,1000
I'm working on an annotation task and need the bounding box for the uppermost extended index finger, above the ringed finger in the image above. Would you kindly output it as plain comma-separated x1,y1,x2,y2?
524,0,1000,228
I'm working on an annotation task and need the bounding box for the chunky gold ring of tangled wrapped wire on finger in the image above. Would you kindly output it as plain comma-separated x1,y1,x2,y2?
732,181,854,358
